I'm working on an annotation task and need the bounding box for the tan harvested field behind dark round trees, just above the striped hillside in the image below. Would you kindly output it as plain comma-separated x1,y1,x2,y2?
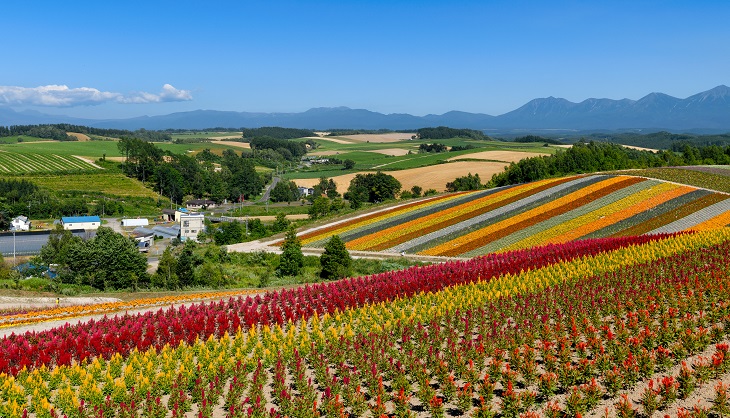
292,161,505,193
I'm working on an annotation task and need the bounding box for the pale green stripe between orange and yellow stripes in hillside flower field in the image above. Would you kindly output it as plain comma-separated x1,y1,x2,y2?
462,180,660,257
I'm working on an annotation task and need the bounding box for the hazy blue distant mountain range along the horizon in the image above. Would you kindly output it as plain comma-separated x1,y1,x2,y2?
0,85,730,132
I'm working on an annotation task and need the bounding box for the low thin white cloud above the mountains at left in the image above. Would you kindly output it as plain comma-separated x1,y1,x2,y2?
0,84,193,107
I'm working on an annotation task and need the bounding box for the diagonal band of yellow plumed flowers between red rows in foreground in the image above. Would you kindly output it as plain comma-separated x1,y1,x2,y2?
0,228,730,417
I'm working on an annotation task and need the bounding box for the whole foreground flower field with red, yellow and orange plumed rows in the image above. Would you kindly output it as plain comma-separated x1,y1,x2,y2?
0,228,730,417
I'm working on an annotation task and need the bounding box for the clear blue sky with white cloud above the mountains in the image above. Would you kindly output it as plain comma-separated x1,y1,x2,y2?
0,0,730,118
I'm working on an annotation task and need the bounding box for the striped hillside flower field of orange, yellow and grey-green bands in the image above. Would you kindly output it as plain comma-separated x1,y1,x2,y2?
299,175,730,257
